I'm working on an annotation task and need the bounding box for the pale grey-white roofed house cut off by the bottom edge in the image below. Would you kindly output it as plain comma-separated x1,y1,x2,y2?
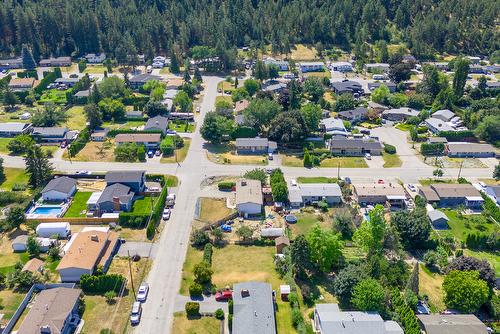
313,304,404,334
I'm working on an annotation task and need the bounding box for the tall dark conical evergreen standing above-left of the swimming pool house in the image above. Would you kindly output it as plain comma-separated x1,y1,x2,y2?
24,145,53,188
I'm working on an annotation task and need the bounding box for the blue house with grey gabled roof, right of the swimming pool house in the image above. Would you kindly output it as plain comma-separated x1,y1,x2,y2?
96,183,135,214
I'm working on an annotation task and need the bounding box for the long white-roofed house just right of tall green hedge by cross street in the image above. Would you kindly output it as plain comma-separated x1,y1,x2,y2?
288,183,342,207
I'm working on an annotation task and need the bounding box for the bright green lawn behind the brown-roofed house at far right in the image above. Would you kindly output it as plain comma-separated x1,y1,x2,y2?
436,209,499,242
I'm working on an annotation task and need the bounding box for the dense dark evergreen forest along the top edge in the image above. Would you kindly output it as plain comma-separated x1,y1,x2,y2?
0,0,500,59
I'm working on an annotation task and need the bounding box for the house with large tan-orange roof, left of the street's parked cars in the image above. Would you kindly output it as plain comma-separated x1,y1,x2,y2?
56,230,118,282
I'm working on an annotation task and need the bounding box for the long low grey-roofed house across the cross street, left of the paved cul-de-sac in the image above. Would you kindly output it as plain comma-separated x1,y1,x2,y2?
328,136,384,156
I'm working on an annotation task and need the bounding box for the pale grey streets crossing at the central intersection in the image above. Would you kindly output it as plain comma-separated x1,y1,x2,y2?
2,77,492,333
